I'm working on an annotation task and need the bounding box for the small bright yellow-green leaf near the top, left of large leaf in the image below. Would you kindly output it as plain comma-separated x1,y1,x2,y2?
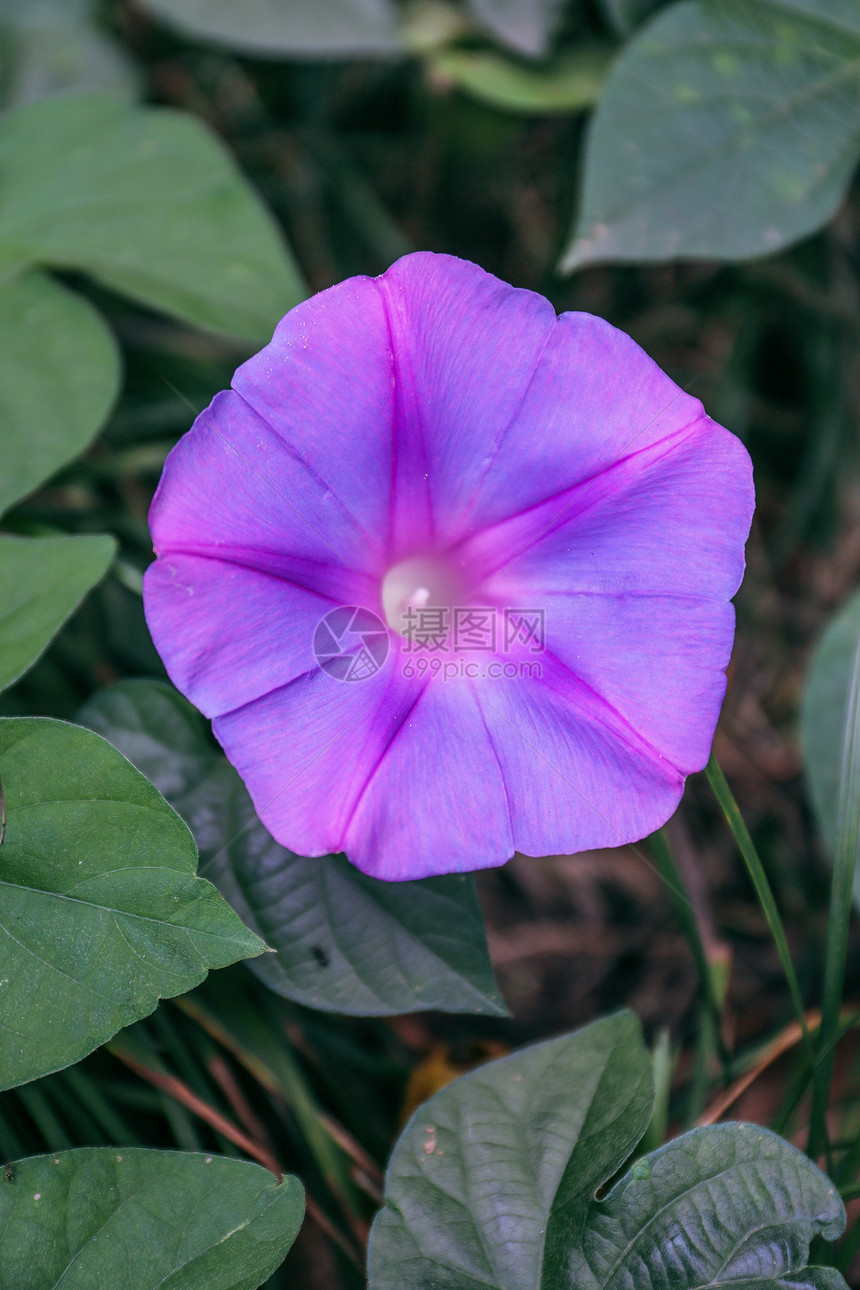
431,45,610,114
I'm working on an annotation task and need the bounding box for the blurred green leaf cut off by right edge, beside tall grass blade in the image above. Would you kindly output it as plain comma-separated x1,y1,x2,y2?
801,592,860,861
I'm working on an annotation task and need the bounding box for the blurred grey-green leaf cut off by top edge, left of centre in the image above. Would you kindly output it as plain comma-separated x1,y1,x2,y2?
134,0,400,58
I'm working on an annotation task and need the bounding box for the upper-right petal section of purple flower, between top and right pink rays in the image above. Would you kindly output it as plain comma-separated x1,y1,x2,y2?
379,253,701,544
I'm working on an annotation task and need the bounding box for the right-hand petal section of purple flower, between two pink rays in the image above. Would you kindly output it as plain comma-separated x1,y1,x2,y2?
472,418,754,775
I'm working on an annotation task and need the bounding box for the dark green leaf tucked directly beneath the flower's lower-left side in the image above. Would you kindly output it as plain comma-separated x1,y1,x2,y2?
80,681,504,1015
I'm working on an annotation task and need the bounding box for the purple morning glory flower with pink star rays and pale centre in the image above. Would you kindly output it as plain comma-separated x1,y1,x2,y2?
144,253,753,878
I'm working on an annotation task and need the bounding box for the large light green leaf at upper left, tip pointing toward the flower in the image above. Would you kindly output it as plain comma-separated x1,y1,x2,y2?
0,94,304,341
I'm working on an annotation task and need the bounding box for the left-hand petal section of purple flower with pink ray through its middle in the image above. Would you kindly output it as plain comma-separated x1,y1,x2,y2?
144,381,387,716
